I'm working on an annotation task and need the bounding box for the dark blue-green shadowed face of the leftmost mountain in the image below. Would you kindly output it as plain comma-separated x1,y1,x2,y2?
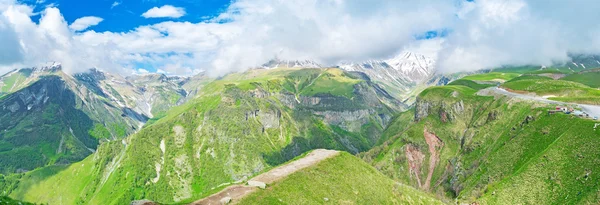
0,76,98,173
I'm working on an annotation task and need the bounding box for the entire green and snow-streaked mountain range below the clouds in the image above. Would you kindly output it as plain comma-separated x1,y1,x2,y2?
0,52,600,204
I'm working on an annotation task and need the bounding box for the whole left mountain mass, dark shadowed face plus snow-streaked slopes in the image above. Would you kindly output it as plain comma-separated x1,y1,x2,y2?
0,64,208,174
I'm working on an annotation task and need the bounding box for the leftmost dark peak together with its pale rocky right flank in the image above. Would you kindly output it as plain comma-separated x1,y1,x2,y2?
0,74,135,174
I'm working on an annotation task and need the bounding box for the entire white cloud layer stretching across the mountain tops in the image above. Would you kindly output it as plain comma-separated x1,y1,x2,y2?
0,0,600,75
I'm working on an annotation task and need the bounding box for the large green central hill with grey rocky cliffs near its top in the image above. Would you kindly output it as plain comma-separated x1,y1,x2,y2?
11,69,402,204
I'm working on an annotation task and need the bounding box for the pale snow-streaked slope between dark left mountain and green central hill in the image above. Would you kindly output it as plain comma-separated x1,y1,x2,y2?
74,69,212,119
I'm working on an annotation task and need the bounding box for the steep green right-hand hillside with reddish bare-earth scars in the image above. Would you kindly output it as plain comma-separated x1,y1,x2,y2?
361,79,600,204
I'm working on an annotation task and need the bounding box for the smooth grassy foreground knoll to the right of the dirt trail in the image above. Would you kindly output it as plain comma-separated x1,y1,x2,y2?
239,153,443,204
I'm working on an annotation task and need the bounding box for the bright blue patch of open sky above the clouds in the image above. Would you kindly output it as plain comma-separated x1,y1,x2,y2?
23,0,230,32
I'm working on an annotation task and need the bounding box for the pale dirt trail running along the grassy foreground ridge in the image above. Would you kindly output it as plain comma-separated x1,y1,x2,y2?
191,149,339,205
